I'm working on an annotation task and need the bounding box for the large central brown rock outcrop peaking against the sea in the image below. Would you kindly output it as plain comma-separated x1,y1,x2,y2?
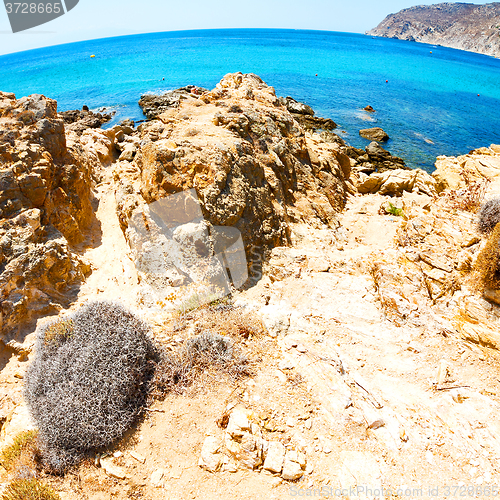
115,73,354,274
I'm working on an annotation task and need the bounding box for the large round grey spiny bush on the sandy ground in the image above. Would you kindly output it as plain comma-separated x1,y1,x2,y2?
25,302,157,472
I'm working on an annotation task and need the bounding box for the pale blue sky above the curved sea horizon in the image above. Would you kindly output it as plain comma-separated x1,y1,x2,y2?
0,0,494,54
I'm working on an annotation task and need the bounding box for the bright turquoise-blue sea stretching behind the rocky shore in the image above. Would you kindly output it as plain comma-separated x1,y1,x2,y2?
0,29,500,171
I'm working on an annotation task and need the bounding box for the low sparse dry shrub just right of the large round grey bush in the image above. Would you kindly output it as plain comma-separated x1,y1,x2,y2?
151,331,252,400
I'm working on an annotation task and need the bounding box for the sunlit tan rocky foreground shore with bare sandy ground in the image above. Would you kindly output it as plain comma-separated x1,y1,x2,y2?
0,73,500,500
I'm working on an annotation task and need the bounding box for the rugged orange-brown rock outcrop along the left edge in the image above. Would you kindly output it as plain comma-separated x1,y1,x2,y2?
0,93,97,340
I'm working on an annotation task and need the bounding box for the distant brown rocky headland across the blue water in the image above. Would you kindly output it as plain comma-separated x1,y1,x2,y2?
367,2,500,57
